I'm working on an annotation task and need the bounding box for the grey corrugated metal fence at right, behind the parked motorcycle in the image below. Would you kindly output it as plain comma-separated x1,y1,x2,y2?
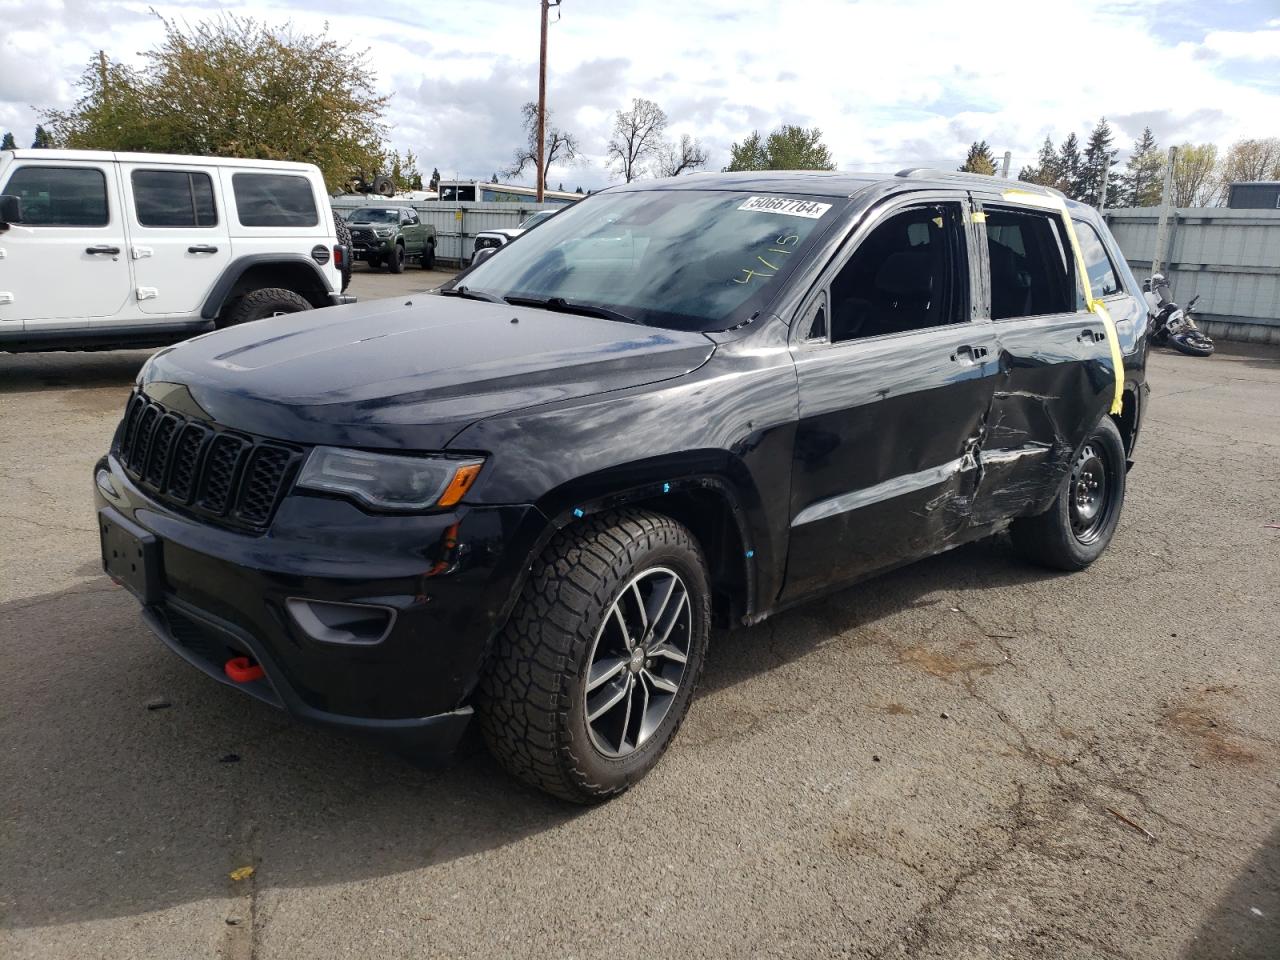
1106,207,1280,343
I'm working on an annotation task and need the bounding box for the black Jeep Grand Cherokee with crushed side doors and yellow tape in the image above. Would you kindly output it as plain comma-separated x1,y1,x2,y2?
96,170,1146,801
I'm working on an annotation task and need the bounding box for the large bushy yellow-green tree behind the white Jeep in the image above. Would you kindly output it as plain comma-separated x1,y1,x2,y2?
42,14,388,189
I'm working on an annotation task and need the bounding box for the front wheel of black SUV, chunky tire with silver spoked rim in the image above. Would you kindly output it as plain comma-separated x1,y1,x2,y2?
477,511,710,804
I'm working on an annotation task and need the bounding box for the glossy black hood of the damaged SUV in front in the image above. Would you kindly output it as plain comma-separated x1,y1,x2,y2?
141,293,714,451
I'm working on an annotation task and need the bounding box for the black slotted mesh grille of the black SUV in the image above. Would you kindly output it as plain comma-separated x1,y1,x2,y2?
118,394,302,530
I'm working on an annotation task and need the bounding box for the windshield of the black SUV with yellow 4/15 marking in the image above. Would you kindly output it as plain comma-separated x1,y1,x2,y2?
462,189,844,330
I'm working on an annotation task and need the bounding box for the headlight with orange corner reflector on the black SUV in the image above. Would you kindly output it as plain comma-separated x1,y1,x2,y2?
298,447,484,511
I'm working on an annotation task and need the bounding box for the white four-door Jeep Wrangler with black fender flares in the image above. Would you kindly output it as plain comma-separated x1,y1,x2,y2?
0,150,353,352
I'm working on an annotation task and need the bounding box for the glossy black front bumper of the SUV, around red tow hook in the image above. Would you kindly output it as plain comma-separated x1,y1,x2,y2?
95,457,545,753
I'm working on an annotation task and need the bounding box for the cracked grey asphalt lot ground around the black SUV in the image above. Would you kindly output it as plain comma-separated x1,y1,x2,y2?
0,299,1280,960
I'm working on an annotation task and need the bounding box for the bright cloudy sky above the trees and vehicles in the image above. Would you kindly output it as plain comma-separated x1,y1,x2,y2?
0,0,1280,189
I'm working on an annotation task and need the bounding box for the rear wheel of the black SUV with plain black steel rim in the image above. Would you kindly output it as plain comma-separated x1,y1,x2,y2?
1009,416,1125,571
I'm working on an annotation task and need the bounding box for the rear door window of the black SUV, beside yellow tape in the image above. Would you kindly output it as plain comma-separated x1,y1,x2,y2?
986,207,1076,320
